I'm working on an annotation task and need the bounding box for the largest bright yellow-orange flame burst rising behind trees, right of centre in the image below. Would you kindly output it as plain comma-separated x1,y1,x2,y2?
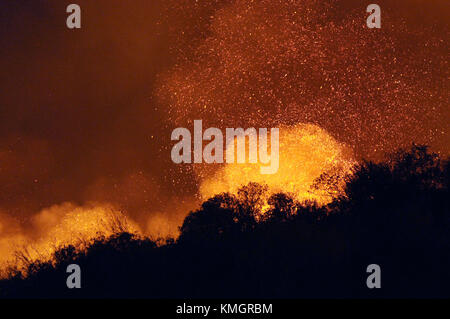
199,124,355,205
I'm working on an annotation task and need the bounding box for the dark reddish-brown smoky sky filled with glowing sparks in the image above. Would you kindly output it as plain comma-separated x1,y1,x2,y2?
0,0,450,229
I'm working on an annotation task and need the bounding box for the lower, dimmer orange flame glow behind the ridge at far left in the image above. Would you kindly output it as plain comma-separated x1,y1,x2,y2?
0,203,141,277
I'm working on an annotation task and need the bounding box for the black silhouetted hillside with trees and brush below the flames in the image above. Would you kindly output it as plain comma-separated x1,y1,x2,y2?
0,146,450,298
